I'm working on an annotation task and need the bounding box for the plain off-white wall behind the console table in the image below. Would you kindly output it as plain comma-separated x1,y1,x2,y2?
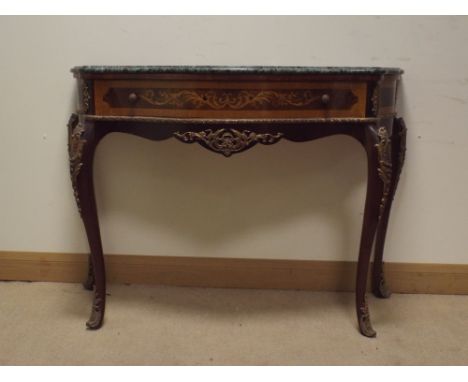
0,17,468,263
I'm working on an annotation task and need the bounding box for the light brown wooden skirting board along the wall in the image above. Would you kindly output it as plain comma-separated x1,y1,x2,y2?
0,251,468,294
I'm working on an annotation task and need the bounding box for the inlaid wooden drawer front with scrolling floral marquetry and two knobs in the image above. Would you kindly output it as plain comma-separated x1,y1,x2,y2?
94,80,367,119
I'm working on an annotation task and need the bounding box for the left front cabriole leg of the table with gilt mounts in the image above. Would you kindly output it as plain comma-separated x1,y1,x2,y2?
69,115,106,329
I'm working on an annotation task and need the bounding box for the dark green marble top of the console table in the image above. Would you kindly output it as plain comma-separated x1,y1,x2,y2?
71,65,403,74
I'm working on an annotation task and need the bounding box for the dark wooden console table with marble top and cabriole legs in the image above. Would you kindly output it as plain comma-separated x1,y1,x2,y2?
68,66,406,337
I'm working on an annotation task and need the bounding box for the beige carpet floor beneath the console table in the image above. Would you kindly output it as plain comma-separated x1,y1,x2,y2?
0,282,468,365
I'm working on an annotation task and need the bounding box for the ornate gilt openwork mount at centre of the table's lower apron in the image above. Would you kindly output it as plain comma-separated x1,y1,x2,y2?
174,128,283,157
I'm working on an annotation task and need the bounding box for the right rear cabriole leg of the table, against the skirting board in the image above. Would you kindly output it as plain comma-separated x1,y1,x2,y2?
372,118,406,298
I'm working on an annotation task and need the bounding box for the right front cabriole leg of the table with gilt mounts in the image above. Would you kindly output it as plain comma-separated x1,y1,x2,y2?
356,125,392,337
